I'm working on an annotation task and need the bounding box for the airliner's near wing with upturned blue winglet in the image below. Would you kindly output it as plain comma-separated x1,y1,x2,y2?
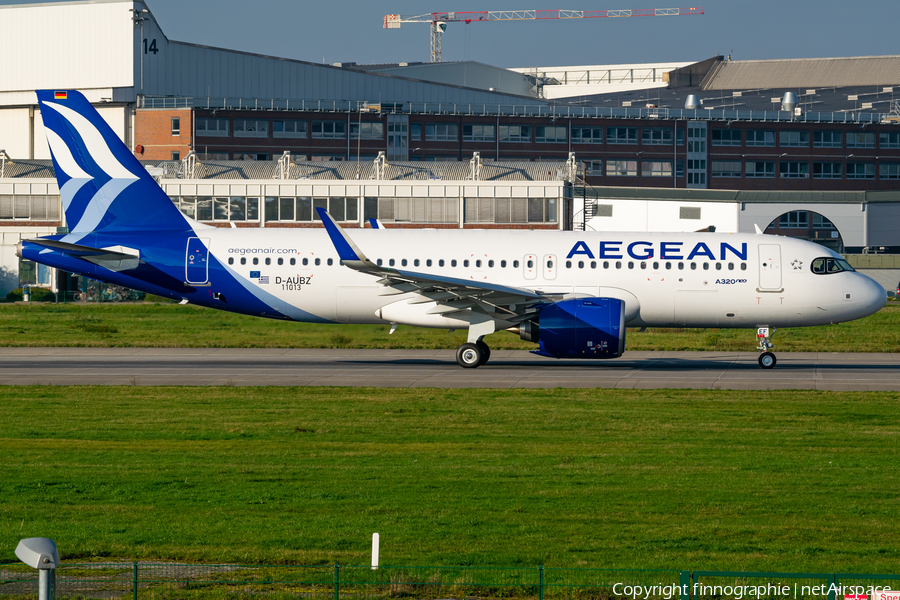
317,208,550,321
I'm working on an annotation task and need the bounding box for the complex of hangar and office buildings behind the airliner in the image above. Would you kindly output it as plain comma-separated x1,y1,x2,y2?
0,0,900,294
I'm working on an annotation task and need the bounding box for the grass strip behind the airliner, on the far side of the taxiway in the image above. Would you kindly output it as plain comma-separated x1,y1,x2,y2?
0,302,900,352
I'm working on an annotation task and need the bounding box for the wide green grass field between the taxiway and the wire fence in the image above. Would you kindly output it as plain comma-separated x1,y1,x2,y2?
0,386,900,573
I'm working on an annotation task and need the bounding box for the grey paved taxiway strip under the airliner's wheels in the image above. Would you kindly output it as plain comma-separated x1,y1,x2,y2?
0,348,900,391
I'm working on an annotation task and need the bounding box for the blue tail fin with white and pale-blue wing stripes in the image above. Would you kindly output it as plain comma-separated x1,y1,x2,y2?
37,90,190,241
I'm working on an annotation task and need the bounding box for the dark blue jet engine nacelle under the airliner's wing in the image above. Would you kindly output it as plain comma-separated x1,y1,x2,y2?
520,298,625,358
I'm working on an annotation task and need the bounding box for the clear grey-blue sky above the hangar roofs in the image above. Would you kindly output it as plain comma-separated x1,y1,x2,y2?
135,0,900,67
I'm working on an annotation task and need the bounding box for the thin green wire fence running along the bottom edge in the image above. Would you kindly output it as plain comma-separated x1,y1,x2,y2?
0,562,900,600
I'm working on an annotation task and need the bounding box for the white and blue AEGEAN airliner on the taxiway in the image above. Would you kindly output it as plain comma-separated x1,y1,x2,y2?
18,91,886,368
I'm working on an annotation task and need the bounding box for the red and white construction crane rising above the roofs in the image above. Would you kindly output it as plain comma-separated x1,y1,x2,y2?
383,6,703,62
